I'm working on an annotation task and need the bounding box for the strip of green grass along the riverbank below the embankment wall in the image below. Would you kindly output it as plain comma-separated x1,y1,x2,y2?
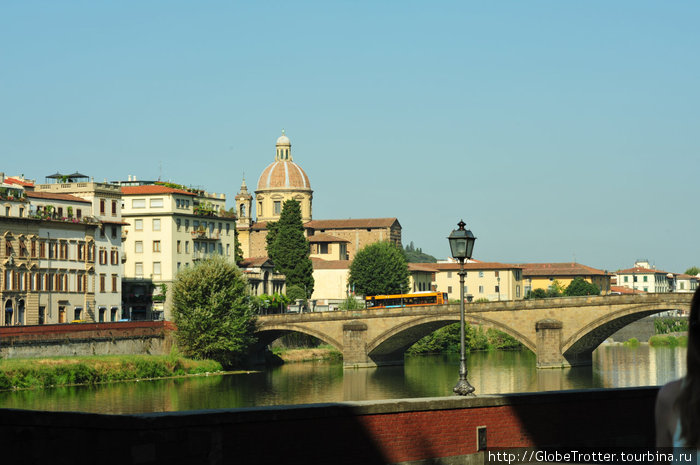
0,353,222,390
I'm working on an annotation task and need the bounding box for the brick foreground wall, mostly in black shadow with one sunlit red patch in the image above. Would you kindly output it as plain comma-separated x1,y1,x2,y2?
0,388,657,465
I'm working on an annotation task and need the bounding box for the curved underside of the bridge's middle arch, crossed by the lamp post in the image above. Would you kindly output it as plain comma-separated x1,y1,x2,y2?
367,314,536,361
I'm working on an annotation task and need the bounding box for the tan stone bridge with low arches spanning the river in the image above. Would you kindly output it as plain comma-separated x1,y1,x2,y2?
257,293,693,368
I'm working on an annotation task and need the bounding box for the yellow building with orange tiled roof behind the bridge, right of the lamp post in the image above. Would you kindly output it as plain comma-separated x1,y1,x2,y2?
519,262,611,295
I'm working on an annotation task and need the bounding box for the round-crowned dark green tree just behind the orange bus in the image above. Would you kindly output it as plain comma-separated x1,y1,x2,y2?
348,242,408,295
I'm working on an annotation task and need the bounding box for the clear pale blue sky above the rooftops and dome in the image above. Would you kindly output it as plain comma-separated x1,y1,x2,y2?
0,0,700,272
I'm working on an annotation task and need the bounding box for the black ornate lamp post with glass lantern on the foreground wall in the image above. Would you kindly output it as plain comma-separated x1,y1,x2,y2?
447,220,476,396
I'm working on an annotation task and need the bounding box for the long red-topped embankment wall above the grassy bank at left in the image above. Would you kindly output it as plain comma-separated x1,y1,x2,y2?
0,321,175,358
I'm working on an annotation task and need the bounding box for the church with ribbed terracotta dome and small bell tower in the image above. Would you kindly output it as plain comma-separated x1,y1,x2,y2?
235,131,401,261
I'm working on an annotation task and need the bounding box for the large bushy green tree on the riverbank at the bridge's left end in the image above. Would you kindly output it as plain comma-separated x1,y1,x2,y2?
171,255,255,367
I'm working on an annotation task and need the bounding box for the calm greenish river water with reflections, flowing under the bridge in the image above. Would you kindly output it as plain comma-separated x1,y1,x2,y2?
0,344,685,413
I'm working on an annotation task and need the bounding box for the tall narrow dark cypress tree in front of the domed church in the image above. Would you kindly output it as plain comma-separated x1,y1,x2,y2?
266,200,314,298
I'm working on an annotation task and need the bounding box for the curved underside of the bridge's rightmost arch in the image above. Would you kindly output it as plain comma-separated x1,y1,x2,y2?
561,302,690,359
